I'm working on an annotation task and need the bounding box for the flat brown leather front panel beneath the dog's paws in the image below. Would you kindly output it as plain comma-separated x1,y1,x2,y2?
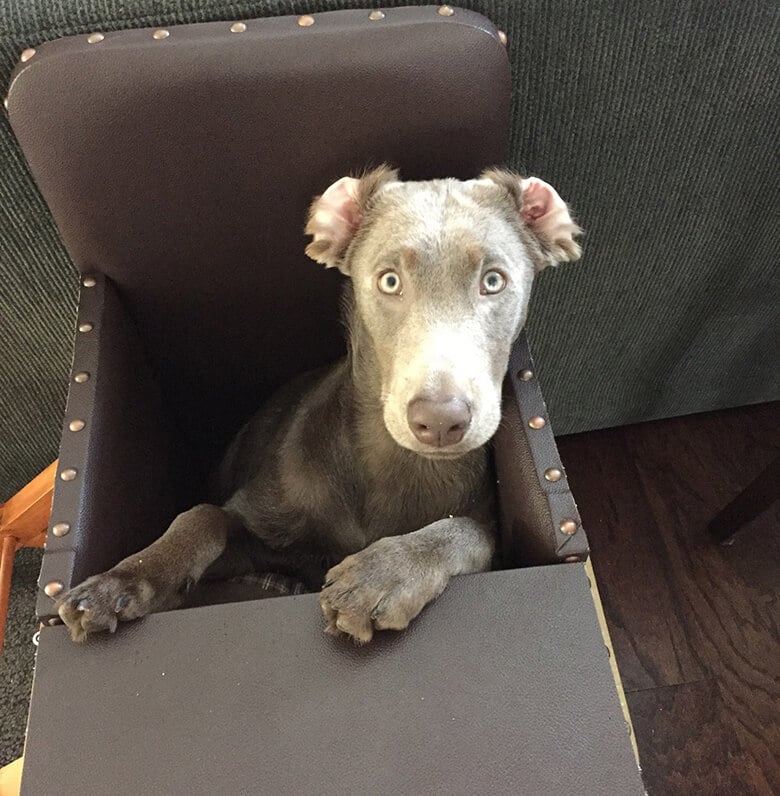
22,565,642,796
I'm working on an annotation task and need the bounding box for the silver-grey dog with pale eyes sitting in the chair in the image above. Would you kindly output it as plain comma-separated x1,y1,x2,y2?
58,167,580,642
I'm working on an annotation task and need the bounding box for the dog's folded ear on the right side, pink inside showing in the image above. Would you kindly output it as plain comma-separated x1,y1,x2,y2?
481,171,582,271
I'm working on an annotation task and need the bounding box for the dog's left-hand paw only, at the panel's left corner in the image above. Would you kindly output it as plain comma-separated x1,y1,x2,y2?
56,570,154,641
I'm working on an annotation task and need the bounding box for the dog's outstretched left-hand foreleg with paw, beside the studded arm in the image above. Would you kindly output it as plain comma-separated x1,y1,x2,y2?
57,503,236,641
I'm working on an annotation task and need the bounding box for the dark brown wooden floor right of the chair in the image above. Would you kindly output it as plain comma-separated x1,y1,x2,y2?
559,404,780,796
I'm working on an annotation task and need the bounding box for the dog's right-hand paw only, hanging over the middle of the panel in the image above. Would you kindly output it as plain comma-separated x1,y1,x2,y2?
320,536,449,644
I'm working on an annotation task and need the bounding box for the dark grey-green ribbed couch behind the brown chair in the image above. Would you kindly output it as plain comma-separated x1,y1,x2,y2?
0,0,780,495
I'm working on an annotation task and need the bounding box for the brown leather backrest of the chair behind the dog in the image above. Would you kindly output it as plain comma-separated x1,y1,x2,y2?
8,7,510,472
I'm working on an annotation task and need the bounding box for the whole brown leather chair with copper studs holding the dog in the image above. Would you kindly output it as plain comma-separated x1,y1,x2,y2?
9,7,642,796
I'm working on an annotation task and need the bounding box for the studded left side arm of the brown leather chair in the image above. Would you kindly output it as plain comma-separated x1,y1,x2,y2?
37,273,187,620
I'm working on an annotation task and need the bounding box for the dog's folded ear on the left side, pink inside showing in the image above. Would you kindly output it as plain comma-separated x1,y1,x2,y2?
306,166,398,273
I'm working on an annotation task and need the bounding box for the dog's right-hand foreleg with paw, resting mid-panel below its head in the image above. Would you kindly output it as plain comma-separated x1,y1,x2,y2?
320,517,496,643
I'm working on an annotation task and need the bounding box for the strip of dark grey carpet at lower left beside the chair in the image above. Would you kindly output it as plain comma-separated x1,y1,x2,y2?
0,548,42,766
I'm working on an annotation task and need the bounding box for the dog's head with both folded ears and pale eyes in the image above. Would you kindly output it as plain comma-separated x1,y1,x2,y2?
306,167,580,458
